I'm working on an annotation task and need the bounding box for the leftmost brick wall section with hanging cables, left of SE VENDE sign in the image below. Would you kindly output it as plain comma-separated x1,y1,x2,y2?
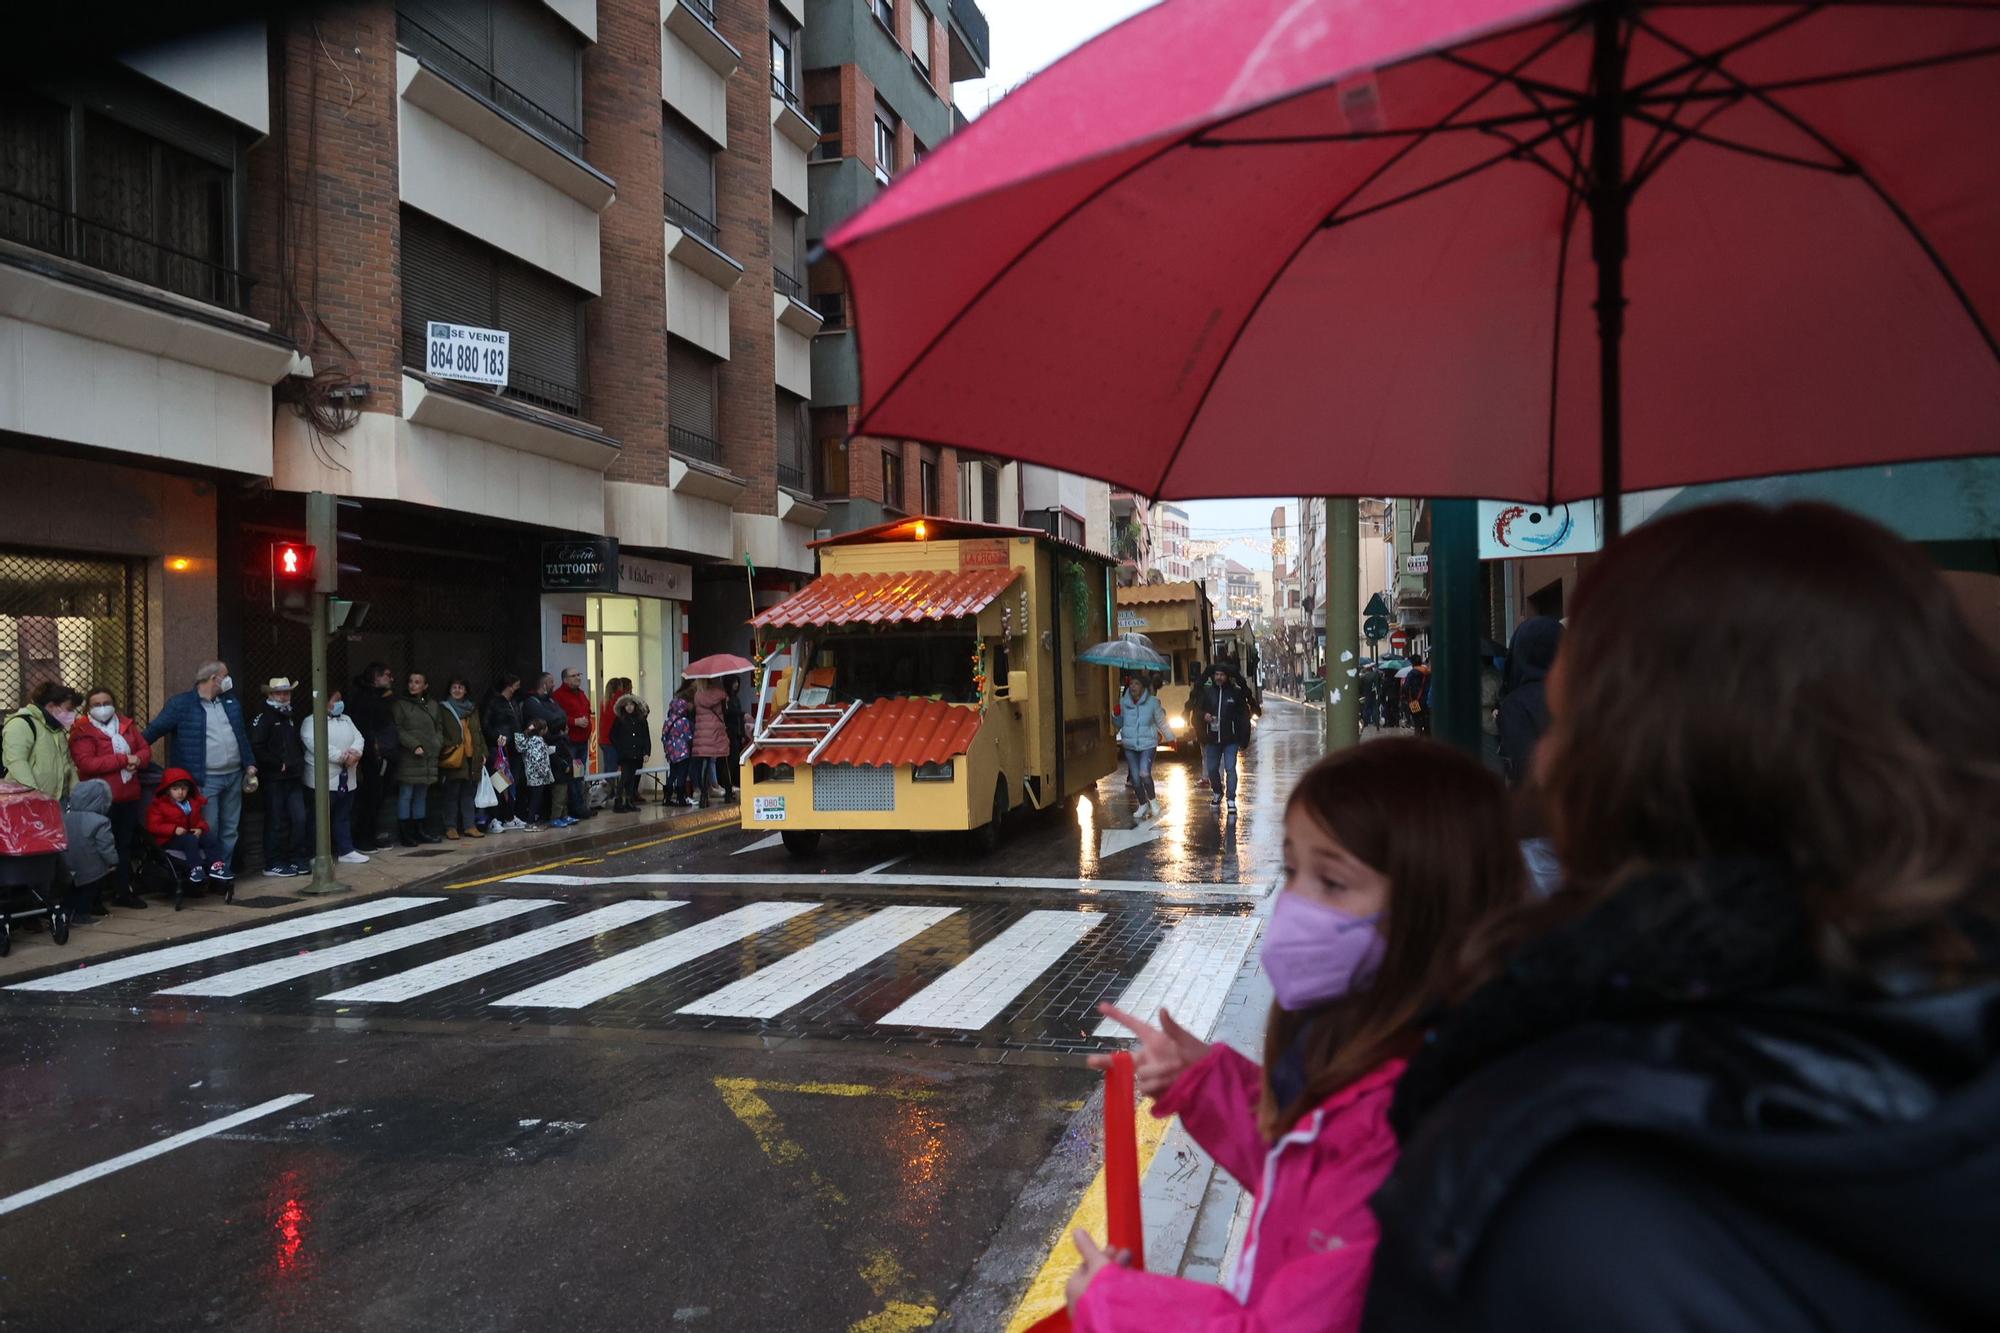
246,4,402,412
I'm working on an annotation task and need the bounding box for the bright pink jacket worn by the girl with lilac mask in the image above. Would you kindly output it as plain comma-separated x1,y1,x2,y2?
1076,1043,1404,1333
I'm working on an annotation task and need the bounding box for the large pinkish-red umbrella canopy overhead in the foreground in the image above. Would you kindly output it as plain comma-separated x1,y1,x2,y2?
828,0,2000,536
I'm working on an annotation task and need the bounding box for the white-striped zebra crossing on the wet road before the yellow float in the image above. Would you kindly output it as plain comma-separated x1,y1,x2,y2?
0,891,1260,1049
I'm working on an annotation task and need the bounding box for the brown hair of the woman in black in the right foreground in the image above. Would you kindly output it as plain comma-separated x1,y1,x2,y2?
1512,504,2000,973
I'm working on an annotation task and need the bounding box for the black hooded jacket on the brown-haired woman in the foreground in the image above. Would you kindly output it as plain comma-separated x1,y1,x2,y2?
1364,867,2000,1333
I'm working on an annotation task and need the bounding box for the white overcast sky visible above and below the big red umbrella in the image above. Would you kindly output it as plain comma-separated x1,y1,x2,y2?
952,0,1298,568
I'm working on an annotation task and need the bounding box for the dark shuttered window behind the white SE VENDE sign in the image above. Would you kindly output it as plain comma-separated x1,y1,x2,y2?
402,208,590,416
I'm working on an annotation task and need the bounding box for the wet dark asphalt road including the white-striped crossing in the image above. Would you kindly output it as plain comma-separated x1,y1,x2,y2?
0,703,1318,1331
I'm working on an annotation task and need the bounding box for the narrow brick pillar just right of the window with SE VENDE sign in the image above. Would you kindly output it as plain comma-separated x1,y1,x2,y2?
584,4,668,486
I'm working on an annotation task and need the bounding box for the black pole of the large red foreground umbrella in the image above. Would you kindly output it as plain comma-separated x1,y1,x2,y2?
1590,2,1630,544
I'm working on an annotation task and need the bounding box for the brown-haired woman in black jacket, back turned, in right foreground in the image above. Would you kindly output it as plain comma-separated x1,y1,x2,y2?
1364,504,2000,1333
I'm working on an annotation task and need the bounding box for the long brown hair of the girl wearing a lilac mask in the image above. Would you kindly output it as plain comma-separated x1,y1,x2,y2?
1258,737,1526,1141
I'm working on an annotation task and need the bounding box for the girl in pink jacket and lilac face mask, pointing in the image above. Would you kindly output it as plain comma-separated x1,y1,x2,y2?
1070,739,1524,1333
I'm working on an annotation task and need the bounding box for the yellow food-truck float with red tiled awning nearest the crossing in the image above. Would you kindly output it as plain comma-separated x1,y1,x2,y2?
742,516,1116,855
